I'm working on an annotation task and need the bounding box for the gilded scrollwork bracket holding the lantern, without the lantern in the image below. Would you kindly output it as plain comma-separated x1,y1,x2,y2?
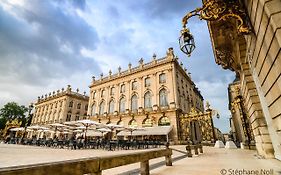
182,0,251,34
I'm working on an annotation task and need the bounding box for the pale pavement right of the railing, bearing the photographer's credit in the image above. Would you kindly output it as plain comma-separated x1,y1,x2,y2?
151,147,281,175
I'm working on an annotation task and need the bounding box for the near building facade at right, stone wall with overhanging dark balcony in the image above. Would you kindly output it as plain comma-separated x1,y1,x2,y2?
203,0,281,160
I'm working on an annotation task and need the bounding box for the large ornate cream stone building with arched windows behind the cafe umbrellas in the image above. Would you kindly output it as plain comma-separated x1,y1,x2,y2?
88,48,204,142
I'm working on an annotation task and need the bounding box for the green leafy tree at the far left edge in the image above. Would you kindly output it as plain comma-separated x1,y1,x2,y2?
0,102,28,129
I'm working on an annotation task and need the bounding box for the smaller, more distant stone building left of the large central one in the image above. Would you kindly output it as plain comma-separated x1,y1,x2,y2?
31,85,89,125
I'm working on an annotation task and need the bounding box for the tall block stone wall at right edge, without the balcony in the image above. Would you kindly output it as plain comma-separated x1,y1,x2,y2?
242,0,281,160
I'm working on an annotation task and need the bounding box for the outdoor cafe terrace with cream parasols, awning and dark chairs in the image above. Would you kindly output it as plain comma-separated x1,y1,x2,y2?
4,120,172,151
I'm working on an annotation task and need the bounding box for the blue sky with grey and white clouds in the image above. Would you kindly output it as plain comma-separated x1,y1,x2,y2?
0,0,234,132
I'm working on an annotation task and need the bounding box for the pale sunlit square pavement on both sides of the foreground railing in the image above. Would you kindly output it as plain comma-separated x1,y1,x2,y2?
0,144,281,175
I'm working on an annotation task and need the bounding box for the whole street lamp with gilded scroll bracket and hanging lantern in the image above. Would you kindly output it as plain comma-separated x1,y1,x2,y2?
179,0,251,56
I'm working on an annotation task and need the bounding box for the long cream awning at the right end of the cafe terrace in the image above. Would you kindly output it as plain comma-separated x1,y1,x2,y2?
117,126,173,136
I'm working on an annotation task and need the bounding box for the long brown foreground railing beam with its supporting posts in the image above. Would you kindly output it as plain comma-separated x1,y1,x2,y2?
0,148,172,175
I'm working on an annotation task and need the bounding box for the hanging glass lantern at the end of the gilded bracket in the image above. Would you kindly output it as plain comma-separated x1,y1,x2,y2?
179,28,195,56
